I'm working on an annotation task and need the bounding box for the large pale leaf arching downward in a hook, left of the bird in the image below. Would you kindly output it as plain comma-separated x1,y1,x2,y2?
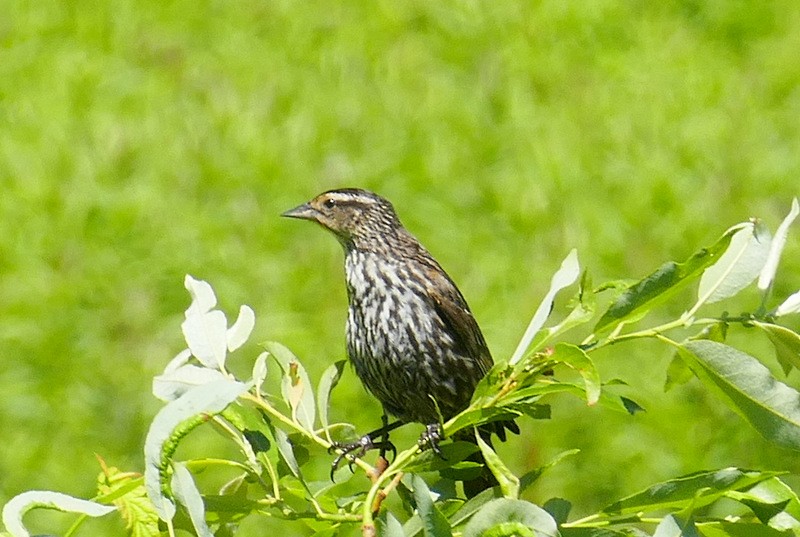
144,379,247,521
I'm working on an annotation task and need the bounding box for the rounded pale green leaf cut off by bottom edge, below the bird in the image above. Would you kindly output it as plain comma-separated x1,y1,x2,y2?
464,498,560,537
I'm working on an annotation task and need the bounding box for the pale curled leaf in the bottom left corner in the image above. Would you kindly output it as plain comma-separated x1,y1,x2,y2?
3,490,116,537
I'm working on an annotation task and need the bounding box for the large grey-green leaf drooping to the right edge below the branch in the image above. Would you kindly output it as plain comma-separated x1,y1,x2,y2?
679,340,800,450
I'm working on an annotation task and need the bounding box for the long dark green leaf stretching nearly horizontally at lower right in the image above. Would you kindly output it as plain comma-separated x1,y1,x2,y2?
600,468,778,516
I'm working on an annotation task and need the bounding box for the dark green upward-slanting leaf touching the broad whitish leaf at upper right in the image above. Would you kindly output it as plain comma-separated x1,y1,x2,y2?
595,225,735,332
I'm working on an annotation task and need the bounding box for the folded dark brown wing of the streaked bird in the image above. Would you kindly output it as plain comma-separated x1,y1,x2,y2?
426,262,492,374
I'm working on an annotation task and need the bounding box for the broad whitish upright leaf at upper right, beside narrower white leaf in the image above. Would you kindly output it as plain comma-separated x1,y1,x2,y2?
697,222,772,304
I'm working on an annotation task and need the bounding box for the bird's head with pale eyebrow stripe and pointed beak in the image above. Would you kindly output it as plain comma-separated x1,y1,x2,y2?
281,188,402,249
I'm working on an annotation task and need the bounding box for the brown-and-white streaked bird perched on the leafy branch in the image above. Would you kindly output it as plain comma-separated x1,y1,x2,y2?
282,188,519,494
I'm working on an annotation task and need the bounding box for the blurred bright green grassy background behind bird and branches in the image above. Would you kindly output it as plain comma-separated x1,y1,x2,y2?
0,0,800,534
